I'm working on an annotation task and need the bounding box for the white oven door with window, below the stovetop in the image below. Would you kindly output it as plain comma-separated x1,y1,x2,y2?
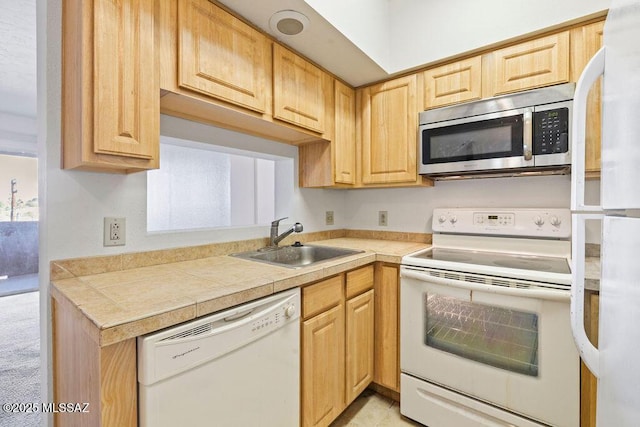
400,266,579,427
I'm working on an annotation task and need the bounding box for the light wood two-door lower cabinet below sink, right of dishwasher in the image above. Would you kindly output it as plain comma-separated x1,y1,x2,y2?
301,265,375,426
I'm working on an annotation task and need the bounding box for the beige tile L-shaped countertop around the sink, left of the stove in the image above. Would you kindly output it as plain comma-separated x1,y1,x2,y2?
51,237,430,347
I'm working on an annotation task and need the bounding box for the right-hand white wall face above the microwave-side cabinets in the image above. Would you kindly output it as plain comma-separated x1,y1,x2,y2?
388,0,611,73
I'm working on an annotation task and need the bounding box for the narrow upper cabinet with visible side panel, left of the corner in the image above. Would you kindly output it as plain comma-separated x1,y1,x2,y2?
298,80,356,187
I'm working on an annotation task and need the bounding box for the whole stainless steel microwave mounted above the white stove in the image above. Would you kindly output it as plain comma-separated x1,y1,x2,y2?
419,83,575,178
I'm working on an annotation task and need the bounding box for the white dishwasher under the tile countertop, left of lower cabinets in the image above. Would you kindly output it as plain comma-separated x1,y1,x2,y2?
138,288,300,427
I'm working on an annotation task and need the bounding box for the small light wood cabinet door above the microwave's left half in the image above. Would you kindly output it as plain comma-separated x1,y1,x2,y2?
424,56,482,109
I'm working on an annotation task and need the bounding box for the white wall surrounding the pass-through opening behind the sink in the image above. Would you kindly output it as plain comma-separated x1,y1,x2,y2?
46,116,345,259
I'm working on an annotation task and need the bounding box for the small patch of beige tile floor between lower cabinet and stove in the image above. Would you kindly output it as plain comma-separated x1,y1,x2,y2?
331,390,422,427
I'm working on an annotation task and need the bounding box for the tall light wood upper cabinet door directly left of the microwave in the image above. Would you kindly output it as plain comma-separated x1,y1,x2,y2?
362,75,419,184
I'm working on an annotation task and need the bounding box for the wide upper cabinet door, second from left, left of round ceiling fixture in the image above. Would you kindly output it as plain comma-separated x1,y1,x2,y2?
178,0,271,113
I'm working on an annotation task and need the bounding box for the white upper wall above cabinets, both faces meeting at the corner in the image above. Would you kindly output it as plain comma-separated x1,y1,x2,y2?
305,0,611,74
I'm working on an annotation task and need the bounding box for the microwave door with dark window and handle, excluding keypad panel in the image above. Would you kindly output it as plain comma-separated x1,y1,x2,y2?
419,108,534,175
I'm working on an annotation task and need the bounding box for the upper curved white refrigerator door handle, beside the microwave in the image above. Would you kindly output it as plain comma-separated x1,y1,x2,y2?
571,46,605,212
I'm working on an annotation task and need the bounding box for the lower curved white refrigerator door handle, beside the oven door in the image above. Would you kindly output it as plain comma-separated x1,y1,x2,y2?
571,214,604,377
